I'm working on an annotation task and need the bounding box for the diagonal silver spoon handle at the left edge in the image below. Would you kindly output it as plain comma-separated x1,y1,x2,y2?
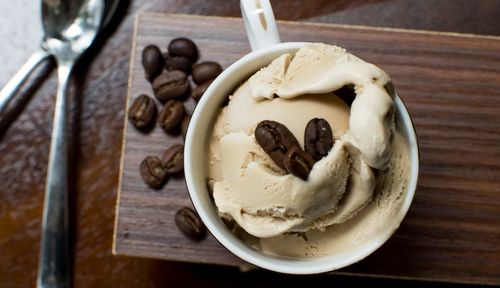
0,49,50,115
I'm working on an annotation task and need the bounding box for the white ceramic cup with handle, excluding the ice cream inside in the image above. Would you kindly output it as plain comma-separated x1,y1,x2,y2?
184,0,419,274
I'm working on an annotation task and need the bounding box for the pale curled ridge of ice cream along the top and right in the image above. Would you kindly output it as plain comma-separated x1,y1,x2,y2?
249,44,394,169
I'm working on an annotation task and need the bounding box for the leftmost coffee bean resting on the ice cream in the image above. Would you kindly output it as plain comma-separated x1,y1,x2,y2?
255,120,300,170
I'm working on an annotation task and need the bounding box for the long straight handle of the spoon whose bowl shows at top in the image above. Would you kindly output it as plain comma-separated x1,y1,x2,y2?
37,61,73,288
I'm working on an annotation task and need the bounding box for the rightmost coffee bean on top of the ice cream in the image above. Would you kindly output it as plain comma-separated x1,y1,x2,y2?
304,118,334,161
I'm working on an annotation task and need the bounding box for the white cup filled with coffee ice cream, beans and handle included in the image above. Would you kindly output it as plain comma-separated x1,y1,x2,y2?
184,0,419,274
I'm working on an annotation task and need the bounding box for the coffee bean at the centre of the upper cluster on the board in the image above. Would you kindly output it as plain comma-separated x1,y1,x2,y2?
153,70,189,102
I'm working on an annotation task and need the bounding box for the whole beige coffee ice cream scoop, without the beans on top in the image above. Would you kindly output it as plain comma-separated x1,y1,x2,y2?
208,44,394,237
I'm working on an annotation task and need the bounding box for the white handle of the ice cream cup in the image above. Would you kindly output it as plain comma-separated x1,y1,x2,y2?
240,0,281,50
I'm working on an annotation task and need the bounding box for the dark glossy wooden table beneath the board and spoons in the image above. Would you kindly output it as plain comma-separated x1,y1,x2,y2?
0,0,500,287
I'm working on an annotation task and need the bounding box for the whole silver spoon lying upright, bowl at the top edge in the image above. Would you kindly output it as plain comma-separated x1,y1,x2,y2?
37,0,104,288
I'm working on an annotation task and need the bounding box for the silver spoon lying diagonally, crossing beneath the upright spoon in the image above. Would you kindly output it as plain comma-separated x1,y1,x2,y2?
0,0,119,116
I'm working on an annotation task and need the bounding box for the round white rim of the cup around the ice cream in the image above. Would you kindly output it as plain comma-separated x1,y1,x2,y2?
184,42,420,274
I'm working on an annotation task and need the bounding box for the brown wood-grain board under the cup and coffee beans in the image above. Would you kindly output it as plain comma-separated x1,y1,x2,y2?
113,13,500,285
